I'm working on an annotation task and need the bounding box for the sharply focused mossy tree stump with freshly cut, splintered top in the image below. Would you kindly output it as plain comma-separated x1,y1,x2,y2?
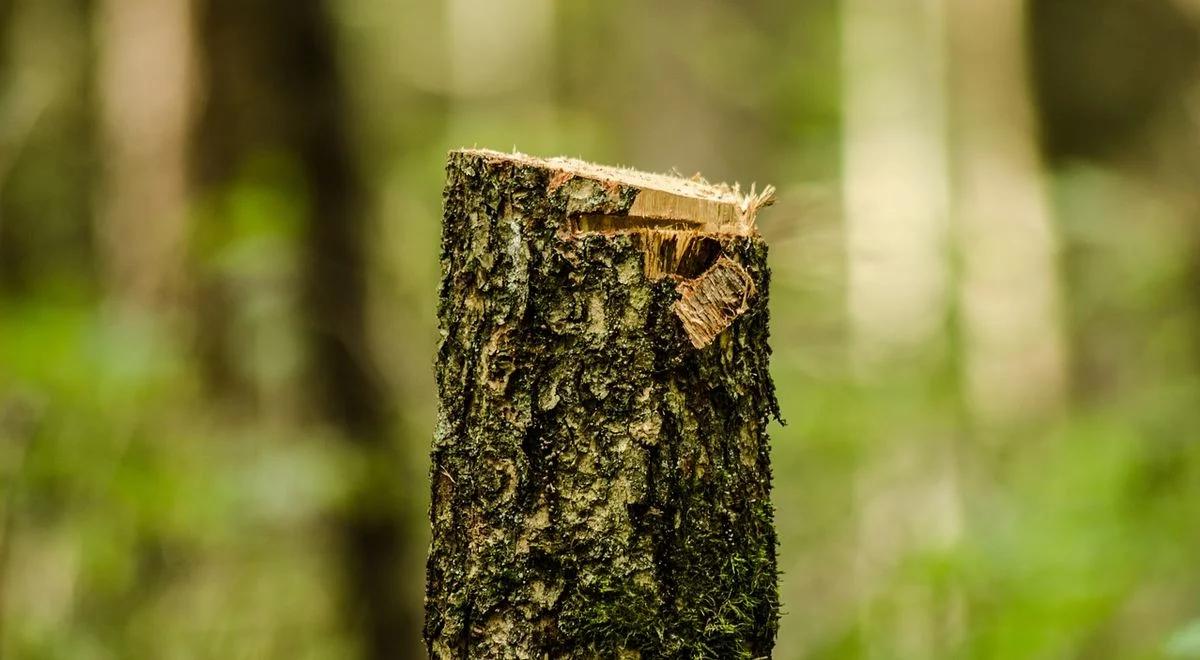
425,150,779,658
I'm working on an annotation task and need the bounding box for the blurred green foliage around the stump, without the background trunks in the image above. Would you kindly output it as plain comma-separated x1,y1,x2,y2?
0,0,1200,659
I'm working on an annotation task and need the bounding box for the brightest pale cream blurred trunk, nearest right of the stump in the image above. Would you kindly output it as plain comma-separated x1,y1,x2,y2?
842,0,949,367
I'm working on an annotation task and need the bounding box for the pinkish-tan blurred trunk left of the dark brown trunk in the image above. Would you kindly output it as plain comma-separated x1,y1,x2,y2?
96,0,192,308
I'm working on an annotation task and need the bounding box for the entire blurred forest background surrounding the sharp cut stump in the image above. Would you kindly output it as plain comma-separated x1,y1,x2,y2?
0,0,1200,659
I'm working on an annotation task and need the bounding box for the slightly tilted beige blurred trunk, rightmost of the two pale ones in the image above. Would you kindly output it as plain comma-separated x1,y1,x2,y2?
949,0,1064,425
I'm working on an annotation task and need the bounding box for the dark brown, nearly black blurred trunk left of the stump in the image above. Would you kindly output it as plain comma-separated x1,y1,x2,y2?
184,0,420,659
